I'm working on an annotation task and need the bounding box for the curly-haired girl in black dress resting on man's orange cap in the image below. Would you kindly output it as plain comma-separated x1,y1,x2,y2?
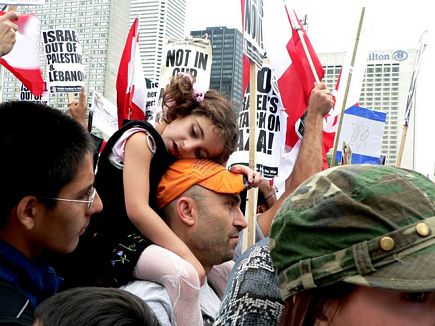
89,74,261,325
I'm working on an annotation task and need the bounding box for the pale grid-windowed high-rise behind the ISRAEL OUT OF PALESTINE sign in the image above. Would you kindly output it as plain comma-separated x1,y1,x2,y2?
1,0,130,109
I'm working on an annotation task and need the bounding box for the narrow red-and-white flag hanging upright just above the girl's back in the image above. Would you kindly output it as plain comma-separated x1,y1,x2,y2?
116,18,147,128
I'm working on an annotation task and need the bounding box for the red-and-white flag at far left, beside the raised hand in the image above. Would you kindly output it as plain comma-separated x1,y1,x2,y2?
0,12,44,96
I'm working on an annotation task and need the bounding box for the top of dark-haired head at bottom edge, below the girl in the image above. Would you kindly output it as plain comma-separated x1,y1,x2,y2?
35,287,160,326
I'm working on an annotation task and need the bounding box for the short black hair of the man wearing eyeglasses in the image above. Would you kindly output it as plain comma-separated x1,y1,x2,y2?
0,101,93,228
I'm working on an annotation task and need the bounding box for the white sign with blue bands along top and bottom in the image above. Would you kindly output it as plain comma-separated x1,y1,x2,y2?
336,106,387,164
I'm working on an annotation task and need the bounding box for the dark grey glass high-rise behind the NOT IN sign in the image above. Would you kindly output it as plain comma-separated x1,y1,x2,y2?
190,27,243,113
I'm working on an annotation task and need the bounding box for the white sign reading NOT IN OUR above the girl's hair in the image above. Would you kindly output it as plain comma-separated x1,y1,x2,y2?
159,38,212,91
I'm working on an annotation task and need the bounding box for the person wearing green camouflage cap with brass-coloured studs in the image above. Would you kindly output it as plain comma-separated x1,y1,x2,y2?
270,165,435,326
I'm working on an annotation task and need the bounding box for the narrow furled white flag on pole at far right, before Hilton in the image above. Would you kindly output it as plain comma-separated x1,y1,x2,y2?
396,31,427,167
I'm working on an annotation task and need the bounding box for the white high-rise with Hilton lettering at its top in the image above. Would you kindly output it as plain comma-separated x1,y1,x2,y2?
319,50,417,169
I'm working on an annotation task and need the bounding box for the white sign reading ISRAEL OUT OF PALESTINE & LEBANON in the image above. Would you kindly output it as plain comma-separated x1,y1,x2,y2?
42,28,85,93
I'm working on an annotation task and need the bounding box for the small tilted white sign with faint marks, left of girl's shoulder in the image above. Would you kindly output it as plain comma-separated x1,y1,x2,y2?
91,92,118,140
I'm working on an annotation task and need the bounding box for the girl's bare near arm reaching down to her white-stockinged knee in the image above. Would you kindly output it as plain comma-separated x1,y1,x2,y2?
123,132,205,284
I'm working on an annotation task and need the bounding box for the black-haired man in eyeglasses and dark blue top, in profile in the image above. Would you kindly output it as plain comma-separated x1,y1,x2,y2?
0,102,103,325
